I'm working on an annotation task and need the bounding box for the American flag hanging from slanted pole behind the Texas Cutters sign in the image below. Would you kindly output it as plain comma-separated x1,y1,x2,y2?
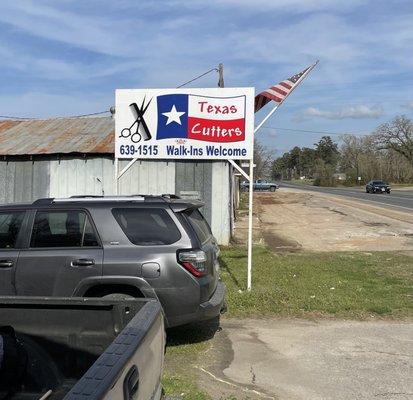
255,61,318,112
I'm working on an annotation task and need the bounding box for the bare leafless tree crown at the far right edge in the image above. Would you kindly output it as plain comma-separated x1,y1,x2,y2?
374,115,413,164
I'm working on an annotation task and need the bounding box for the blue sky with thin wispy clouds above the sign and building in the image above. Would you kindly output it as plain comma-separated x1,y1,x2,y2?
0,0,413,153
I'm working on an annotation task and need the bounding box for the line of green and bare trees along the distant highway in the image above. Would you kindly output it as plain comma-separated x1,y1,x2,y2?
268,116,413,186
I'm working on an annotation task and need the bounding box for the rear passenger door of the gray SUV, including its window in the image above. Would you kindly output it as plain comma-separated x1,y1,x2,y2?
16,210,103,296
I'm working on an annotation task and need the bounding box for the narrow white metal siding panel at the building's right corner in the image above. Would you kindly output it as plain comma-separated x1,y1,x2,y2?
211,162,231,245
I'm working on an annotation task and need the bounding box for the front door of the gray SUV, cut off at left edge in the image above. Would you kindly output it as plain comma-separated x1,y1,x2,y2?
0,210,26,296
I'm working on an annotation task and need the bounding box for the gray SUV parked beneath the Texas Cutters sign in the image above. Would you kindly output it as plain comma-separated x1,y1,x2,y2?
0,195,225,327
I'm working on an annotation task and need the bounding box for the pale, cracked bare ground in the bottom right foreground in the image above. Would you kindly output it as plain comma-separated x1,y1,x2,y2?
195,319,413,400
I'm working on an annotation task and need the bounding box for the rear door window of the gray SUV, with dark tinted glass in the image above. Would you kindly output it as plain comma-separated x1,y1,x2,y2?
30,210,99,247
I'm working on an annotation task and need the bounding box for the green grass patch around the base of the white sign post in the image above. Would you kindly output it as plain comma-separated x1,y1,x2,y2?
221,247,413,318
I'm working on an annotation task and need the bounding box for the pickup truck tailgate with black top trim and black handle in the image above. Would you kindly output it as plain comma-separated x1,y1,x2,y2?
64,301,165,400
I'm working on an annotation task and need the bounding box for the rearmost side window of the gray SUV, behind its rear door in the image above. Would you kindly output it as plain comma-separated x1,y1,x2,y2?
112,208,181,246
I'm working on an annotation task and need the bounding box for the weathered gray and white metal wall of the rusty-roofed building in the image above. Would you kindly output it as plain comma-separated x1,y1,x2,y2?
0,155,231,245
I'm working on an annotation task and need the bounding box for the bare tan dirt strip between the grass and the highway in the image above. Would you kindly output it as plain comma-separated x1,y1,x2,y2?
235,188,413,252
